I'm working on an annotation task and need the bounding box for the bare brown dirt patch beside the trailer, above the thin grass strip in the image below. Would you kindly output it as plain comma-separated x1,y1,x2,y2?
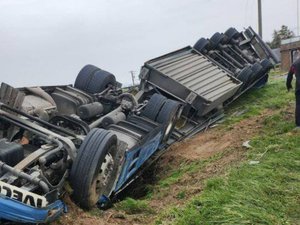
160,110,274,166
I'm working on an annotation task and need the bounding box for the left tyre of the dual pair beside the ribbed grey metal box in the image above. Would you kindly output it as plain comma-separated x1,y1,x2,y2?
142,93,167,121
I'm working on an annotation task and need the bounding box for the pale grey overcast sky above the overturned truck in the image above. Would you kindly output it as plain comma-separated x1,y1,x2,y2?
0,0,297,87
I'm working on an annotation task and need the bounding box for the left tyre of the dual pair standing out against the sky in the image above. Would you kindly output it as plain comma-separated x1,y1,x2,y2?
74,65,100,91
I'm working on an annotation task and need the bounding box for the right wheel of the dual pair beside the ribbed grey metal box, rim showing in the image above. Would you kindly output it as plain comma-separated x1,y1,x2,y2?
156,99,180,141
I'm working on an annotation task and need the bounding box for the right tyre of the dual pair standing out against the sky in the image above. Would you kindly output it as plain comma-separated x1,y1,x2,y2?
86,70,117,94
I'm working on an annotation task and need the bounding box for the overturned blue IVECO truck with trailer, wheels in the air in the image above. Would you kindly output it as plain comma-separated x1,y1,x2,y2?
0,27,278,223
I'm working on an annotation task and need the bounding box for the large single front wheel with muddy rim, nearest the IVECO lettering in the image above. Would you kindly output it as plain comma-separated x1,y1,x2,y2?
70,128,117,209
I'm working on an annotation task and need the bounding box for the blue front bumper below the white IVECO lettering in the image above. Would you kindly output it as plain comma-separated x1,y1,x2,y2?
0,196,66,223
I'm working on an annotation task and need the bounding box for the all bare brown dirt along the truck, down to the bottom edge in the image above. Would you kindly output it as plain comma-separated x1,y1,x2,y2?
56,110,275,225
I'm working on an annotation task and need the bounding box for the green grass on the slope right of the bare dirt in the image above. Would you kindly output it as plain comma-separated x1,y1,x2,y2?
156,76,300,225
